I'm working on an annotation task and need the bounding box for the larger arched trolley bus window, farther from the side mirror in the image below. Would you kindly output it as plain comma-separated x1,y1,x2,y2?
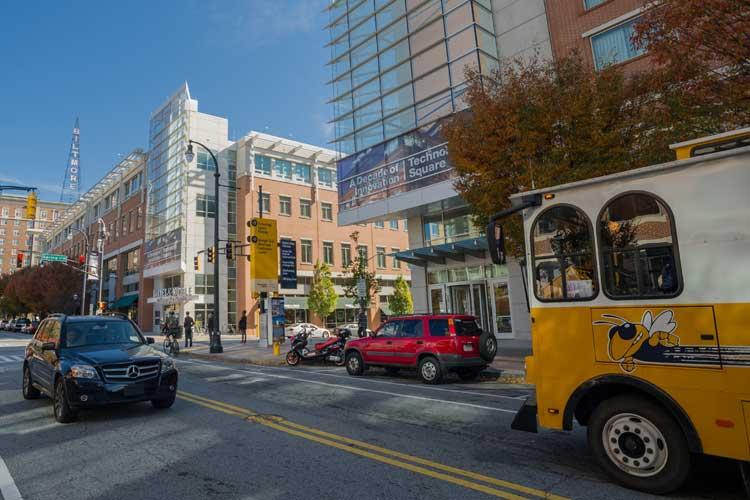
599,193,681,299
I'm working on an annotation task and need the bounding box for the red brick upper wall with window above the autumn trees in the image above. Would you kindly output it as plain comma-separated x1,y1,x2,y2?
545,0,652,74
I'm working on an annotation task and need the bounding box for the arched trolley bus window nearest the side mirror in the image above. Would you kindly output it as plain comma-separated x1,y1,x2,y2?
531,205,597,301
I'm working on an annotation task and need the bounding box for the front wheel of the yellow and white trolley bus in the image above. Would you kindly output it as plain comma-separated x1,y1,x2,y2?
588,395,691,495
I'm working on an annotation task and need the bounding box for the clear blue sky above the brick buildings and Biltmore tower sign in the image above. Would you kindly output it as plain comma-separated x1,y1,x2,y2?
0,0,332,200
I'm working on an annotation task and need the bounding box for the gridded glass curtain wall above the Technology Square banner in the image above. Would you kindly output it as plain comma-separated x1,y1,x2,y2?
328,0,499,156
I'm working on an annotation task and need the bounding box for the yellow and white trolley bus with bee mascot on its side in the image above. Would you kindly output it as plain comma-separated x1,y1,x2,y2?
487,129,750,495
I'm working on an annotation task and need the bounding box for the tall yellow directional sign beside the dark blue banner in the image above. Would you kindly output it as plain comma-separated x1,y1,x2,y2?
248,217,279,293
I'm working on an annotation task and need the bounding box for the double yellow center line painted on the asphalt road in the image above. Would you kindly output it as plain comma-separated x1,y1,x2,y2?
178,391,567,500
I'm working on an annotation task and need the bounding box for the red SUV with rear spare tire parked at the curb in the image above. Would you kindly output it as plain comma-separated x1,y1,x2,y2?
345,314,497,384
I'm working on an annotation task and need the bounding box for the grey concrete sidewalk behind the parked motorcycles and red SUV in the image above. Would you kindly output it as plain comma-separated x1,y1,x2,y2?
160,335,531,383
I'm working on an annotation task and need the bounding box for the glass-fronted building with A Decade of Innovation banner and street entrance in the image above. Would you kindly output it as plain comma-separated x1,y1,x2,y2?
327,0,551,341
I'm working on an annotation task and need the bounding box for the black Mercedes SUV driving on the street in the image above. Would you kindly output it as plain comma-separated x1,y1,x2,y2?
23,314,177,423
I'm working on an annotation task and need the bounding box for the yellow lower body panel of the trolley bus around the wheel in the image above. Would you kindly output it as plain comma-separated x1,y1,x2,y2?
527,304,750,460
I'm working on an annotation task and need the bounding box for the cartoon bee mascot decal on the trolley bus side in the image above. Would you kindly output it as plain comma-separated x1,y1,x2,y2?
594,310,680,373
